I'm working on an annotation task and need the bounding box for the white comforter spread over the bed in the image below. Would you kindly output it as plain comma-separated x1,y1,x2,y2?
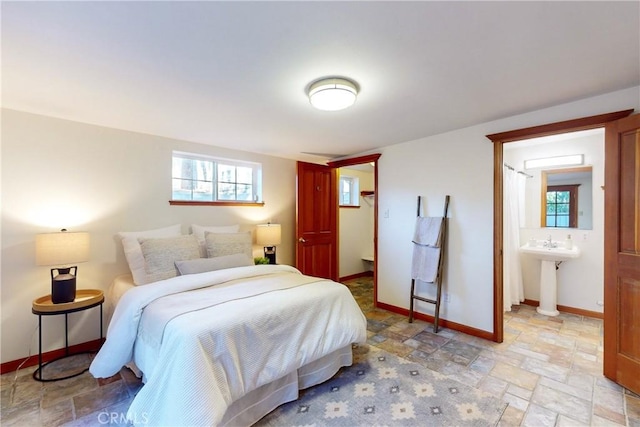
90,265,366,426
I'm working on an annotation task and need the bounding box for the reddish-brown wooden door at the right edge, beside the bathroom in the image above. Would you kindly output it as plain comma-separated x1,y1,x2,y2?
604,114,640,393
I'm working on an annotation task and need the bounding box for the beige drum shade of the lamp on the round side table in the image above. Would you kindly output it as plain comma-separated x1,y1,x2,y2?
36,231,89,266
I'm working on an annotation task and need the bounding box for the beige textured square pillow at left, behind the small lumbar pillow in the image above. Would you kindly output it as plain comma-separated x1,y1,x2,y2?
138,235,200,283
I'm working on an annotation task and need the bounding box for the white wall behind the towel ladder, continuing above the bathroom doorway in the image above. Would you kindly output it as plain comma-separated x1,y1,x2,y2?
377,87,640,332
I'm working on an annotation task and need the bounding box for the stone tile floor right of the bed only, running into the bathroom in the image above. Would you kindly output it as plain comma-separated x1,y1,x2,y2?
345,278,640,427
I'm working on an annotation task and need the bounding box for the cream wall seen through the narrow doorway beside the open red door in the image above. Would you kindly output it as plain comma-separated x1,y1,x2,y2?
338,168,374,277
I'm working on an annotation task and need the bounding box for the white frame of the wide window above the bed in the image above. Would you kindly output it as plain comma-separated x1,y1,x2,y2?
171,151,263,204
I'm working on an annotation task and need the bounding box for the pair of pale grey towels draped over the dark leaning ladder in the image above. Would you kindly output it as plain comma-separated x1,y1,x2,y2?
411,217,443,283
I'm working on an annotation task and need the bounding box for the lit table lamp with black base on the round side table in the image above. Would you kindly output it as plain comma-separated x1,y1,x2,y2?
36,228,89,304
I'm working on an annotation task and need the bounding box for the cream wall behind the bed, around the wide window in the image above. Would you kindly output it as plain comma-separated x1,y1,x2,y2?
0,110,296,362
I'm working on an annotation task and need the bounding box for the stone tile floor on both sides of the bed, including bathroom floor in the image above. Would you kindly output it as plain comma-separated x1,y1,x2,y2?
0,278,640,427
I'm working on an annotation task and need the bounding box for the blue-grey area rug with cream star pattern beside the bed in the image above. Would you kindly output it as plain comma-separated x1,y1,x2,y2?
256,346,507,427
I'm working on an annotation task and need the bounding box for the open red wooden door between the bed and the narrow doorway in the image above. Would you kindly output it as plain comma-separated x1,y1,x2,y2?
296,162,338,281
